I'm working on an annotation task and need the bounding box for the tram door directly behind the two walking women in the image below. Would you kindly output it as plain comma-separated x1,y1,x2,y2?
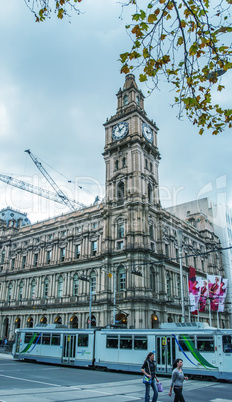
156,336,176,373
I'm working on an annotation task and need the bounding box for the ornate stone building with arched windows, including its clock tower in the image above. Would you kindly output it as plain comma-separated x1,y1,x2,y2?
0,74,228,338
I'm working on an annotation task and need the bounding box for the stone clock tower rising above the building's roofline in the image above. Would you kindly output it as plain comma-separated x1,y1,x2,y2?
103,74,160,206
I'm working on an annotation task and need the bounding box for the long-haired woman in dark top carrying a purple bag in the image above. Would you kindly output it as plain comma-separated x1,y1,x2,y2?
141,352,159,402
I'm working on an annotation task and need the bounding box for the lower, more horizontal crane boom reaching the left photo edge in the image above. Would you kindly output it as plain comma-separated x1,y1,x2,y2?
0,174,86,210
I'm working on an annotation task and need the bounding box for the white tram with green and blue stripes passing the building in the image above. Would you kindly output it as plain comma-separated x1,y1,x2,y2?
13,323,232,380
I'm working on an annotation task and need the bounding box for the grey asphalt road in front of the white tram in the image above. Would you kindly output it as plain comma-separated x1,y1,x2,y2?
0,354,232,402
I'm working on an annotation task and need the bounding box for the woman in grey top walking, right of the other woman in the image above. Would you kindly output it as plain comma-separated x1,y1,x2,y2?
168,359,188,402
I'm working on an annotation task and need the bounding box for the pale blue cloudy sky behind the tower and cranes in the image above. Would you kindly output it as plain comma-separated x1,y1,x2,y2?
0,0,232,222
